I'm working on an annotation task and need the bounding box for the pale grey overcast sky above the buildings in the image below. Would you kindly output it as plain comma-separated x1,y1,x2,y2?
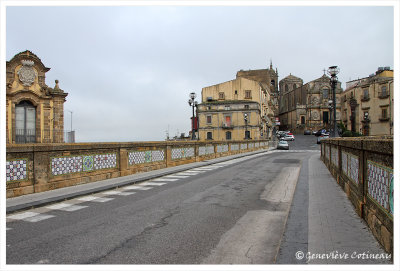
6,3,394,142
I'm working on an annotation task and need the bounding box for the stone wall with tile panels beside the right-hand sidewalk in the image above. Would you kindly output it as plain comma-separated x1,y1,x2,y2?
321,137,394,253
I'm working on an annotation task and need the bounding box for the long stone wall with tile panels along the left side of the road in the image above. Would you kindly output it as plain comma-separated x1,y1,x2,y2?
6,140,274,197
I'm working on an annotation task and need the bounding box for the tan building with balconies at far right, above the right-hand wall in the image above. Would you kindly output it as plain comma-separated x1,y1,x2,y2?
340,67,394,136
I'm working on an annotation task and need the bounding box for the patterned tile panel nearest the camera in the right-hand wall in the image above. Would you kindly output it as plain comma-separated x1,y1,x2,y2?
367,160,393,215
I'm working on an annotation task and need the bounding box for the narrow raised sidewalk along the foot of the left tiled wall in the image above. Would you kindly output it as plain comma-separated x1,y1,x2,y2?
6,148,275,214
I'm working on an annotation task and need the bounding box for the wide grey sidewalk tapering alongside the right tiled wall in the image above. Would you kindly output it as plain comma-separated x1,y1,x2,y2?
303,155,392,264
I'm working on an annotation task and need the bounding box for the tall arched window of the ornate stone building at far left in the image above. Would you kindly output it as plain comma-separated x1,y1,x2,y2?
15,101,36,143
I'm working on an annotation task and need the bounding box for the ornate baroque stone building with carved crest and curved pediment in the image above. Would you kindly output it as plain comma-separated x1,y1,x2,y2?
6,51,68,144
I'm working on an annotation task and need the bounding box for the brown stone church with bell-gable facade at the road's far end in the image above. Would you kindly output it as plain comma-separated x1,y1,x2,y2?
279,74,342,134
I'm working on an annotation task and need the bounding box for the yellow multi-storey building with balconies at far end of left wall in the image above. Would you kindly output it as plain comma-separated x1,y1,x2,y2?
197,72,274,140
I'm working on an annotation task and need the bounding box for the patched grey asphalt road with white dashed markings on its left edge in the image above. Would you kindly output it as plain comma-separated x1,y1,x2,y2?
6,149,319,264
